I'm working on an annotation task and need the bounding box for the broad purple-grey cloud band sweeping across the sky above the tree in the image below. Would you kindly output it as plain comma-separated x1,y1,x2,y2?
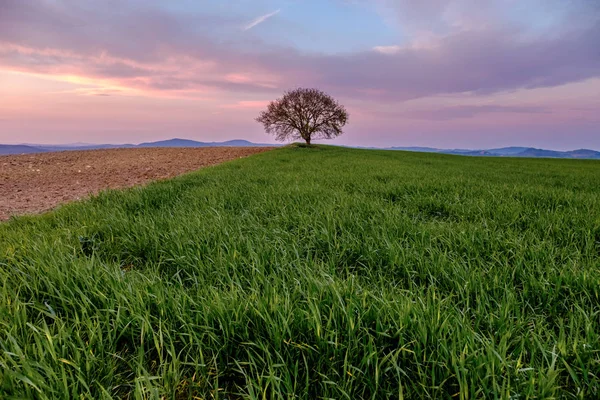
0,0,600,101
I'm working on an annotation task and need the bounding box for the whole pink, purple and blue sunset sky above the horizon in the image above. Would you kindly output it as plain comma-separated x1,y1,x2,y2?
0,0,600,150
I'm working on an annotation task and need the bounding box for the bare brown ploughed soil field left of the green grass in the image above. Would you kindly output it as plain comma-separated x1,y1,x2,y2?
0,147,270,220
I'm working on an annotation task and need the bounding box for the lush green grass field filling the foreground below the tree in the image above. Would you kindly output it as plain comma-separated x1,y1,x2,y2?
0,146,600,399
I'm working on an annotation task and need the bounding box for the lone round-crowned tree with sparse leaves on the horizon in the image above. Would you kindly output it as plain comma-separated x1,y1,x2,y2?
256,89,348,145
